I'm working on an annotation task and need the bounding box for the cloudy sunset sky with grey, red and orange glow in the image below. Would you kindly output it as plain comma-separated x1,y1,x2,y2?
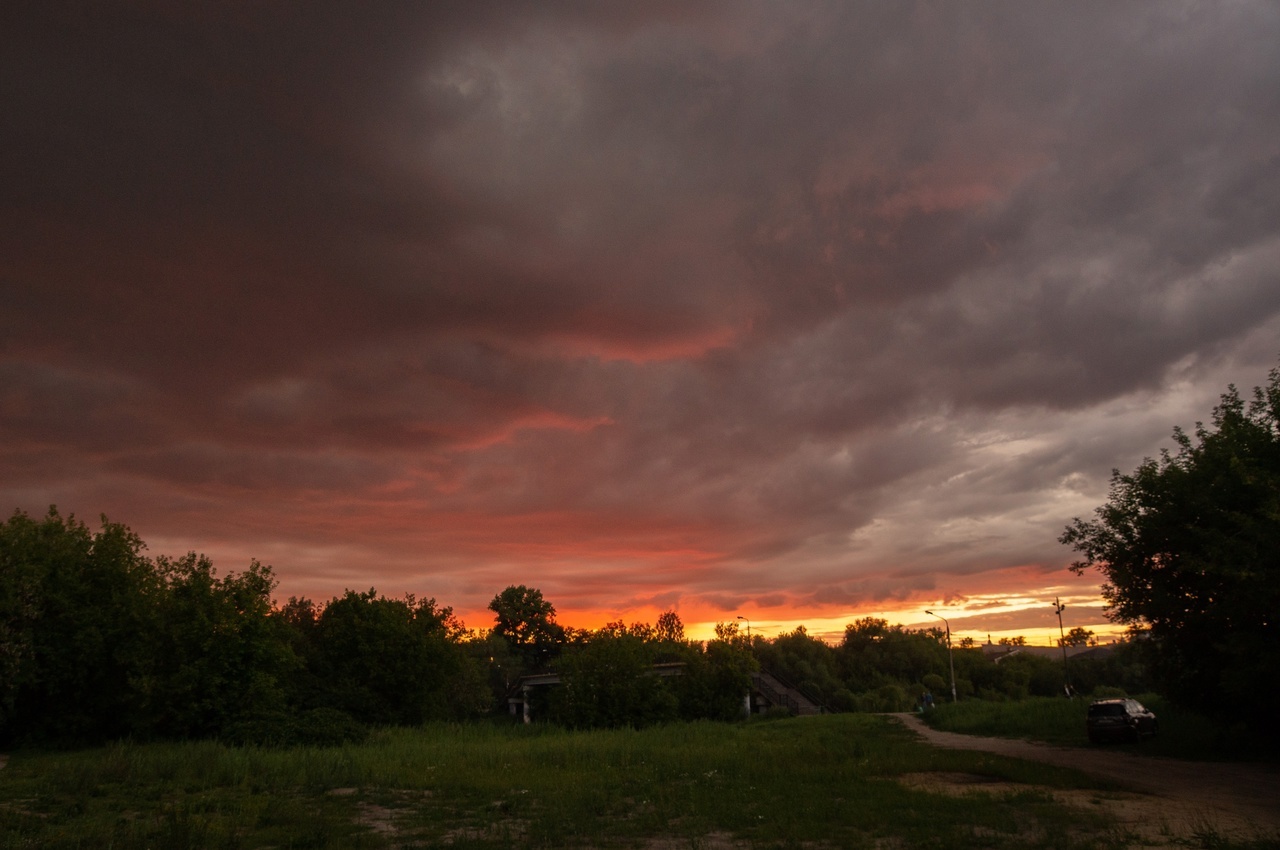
0,0,1280,643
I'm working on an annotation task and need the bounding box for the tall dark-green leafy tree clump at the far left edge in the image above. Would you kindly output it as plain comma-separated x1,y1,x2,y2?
0,507,296,744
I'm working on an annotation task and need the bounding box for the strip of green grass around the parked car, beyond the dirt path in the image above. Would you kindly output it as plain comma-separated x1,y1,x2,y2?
924,694,1280,762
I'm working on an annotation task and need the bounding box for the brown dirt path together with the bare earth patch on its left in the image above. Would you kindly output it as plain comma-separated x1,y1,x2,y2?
895,714,1280,847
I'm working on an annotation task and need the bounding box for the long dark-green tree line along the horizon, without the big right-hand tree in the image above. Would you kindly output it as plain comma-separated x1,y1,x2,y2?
0,508,1141,745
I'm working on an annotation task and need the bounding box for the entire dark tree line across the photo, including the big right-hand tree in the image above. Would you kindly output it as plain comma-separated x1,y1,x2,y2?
0,370,1280,744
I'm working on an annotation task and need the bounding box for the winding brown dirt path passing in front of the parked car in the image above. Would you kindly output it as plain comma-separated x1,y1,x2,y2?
893,714,1280,838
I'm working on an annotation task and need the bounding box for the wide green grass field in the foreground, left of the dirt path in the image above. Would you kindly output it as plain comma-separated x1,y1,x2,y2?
0,714,1124,850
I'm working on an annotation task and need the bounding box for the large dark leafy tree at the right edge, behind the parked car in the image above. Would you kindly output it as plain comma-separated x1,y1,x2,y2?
1060,369,1280,728
